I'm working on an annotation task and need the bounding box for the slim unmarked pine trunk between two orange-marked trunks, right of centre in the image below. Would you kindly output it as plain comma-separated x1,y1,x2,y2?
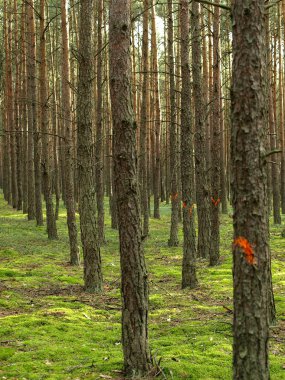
191,1,210,257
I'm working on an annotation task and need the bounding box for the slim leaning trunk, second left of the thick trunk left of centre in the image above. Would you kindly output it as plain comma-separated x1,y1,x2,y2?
40,0,58,239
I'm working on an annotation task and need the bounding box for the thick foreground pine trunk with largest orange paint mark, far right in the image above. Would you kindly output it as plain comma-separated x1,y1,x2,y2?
231,0,270,380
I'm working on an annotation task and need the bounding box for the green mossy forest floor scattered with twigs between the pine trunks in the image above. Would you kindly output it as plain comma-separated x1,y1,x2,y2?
0,195,285,380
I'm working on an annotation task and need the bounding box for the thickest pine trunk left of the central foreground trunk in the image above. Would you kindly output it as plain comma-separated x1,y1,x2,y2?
77,0,103,292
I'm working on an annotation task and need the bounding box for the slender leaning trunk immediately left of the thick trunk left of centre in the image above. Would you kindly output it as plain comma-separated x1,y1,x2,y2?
61,0,79,265
